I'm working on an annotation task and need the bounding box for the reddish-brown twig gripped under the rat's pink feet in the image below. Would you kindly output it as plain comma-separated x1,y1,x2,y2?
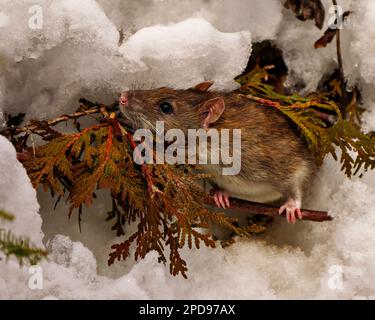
204,196,333,222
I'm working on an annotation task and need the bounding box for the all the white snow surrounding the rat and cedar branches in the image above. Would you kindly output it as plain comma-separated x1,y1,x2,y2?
0,0,375,299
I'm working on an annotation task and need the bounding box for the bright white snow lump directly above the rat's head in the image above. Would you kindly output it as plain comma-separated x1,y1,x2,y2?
120,19,251,88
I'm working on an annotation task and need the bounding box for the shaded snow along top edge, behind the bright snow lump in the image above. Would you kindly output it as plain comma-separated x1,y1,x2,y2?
98,0,282,41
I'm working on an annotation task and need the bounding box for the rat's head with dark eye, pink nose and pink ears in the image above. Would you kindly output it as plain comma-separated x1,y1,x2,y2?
119,81,225,131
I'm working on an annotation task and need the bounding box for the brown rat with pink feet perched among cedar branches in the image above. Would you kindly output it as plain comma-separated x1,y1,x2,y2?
119,81,314,224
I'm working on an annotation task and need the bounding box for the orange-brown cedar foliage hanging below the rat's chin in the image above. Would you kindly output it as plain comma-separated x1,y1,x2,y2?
24,118,249,278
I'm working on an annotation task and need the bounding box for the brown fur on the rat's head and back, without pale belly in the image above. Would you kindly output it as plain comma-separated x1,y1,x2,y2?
123,88,314,204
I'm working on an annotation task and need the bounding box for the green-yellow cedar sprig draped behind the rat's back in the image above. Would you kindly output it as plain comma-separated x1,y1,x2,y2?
236,67,375,177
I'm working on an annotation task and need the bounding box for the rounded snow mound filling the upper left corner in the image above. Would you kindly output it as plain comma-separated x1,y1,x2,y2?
0,0,119,62
